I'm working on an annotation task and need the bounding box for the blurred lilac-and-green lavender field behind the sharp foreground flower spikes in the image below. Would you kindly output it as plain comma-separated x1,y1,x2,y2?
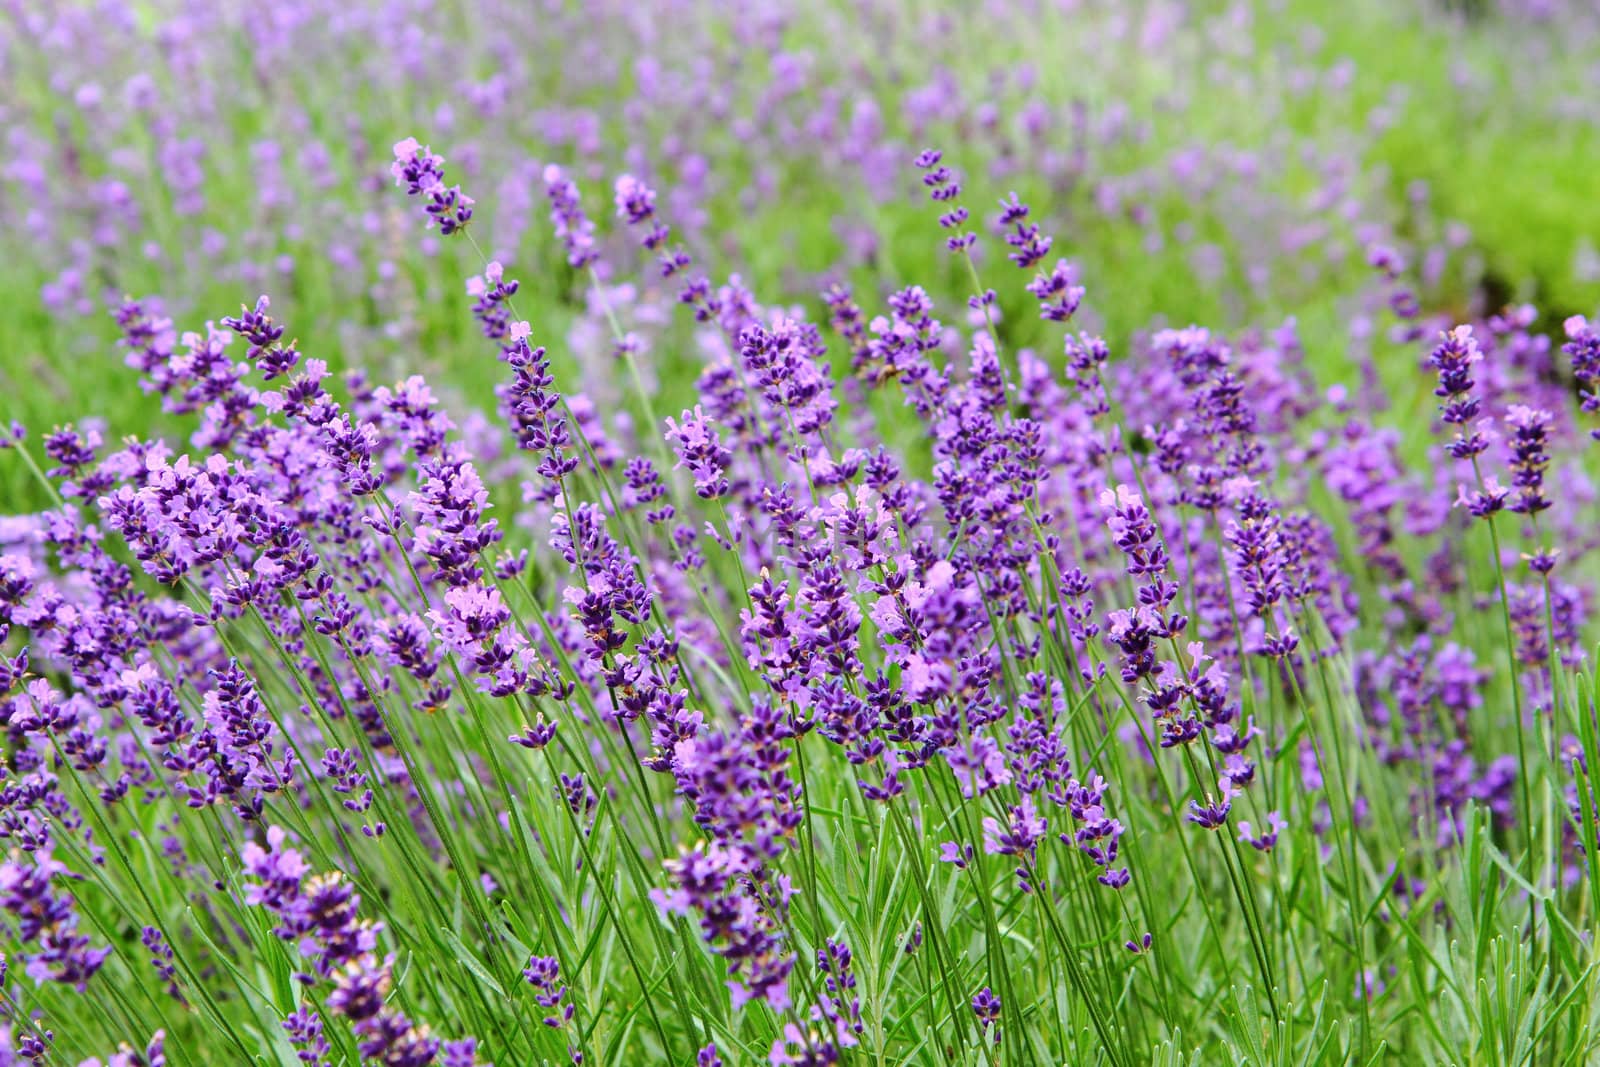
0,0,1600,496
